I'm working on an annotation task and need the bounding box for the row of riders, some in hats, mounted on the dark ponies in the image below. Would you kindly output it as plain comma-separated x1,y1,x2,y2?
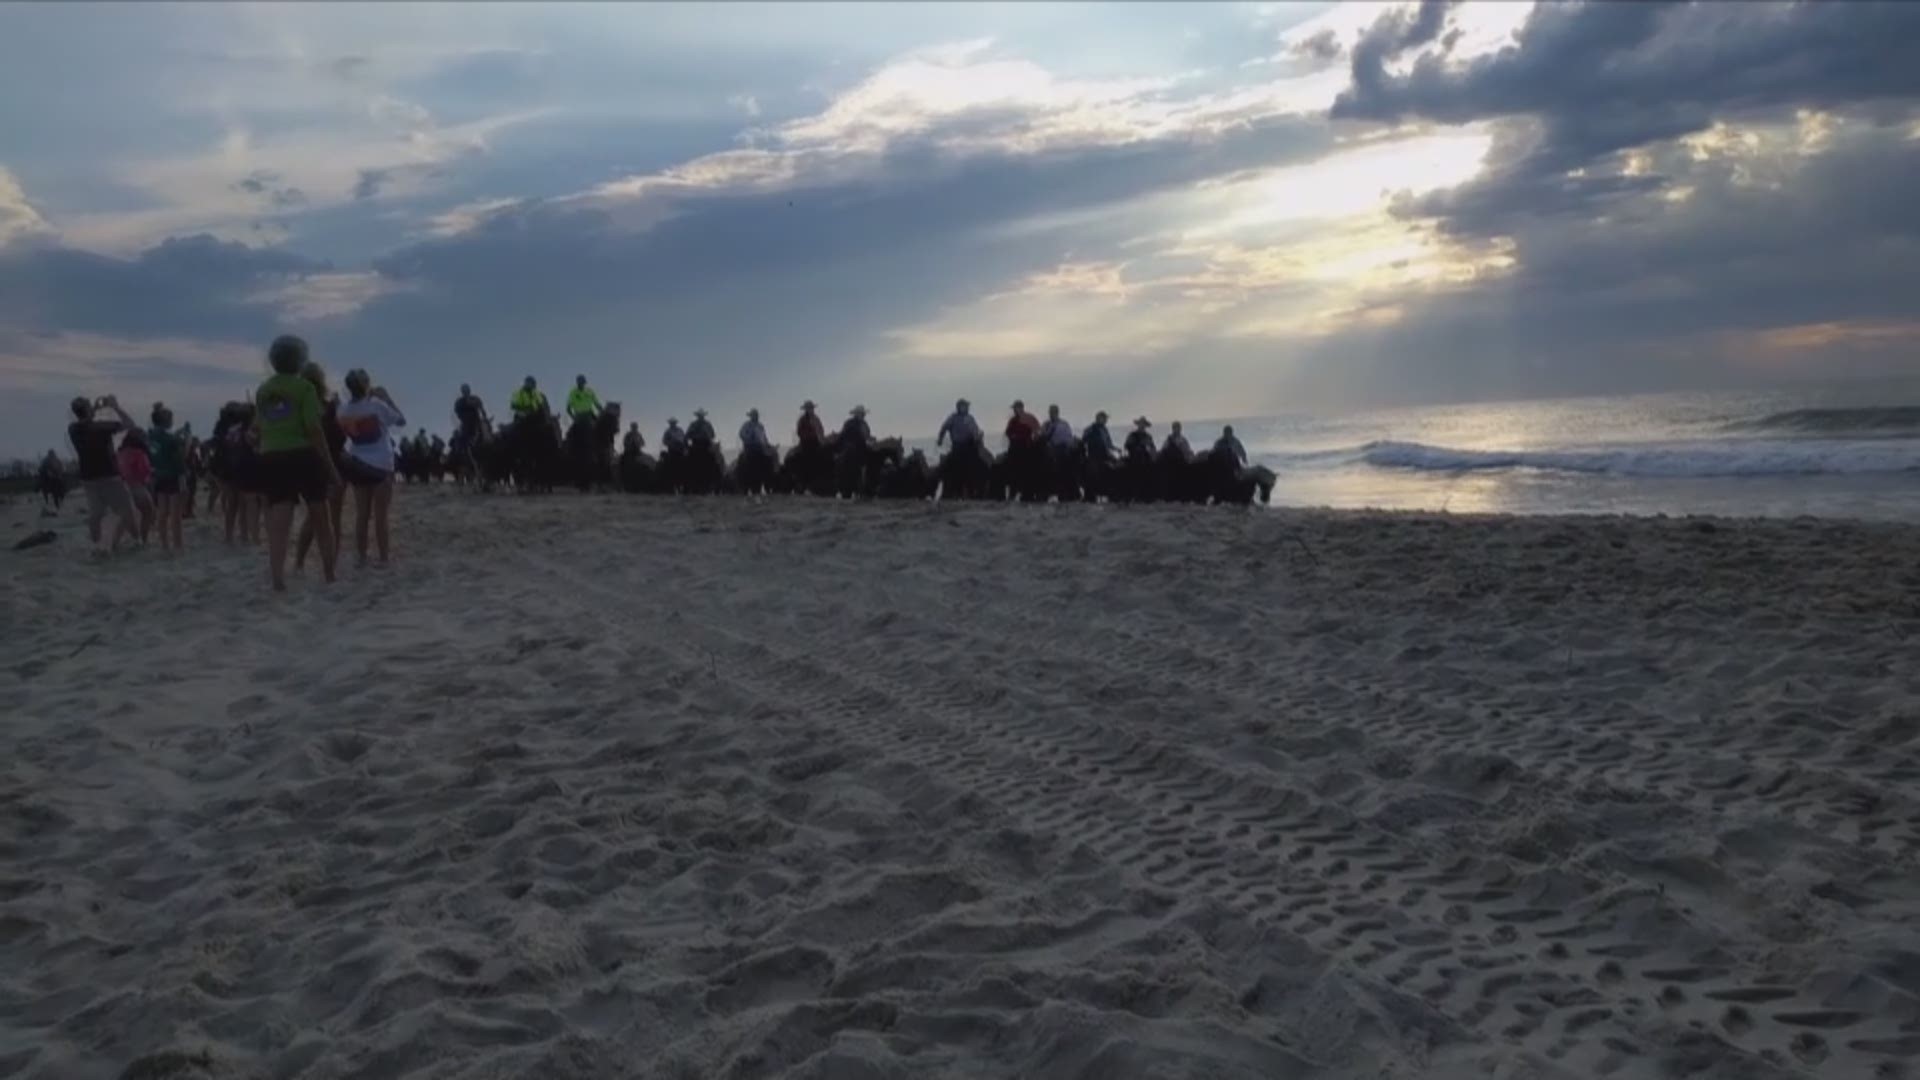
453,375,1246,467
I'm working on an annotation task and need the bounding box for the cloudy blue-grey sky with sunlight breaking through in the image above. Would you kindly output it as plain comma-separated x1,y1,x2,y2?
0,0,1920,455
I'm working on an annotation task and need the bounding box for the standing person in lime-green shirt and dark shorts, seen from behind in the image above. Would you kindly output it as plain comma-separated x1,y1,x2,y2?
253,334,340,592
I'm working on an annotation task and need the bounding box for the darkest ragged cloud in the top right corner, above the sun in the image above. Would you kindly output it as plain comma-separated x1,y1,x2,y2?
1332,2,1920,234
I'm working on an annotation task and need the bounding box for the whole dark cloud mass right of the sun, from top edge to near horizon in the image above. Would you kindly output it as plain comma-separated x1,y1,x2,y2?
1311,2,1920,400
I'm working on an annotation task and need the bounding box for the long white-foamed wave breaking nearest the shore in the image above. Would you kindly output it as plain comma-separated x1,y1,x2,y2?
1359,440,1920,477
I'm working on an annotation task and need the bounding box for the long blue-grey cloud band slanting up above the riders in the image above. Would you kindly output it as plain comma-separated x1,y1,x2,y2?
330,117,1329,404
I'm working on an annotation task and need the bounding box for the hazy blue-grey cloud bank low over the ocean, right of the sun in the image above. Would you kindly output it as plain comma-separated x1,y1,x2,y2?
1313,123,1920,402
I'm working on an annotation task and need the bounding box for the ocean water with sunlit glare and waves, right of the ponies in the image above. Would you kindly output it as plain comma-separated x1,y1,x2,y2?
1190,382,1920,521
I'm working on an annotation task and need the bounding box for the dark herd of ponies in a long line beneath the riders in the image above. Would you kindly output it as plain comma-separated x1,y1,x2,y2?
428,404,1275,505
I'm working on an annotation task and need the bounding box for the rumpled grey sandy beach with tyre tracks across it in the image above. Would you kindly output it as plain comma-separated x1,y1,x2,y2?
0,490,1920,1080
